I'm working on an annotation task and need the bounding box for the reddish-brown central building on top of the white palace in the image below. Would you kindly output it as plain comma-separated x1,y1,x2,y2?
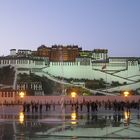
35,45,82,62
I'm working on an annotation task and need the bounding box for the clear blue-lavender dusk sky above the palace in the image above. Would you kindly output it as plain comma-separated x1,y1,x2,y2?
0,0,140,56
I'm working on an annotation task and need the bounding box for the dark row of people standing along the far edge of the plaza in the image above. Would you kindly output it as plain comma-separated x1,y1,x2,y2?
23,100,140,113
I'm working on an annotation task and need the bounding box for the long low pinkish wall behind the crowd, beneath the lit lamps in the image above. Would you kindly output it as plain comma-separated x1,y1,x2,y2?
0,96,140,104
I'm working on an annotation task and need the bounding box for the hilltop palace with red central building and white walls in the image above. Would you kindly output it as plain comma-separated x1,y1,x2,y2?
0,45,140,95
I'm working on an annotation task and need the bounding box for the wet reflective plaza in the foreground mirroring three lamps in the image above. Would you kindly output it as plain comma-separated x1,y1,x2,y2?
0,105,140,140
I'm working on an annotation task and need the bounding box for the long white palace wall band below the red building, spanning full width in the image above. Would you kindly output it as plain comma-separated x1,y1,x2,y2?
0,59,140,83
